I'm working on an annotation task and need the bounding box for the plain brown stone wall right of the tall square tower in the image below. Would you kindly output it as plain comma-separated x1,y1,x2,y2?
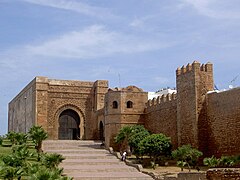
207,88,240,157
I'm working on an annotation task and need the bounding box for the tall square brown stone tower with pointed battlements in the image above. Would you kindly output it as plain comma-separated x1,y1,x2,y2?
176,61,214,150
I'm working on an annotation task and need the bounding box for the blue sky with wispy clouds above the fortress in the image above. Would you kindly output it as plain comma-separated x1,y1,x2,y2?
0,0,240,134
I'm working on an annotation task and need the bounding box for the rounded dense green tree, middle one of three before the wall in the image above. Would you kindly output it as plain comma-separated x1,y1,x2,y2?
139,133,172,164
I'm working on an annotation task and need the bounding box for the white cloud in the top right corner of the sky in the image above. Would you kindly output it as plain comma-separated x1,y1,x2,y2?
181,0,240,19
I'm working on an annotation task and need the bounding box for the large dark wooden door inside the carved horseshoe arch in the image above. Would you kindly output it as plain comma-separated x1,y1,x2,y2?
58,109,80,140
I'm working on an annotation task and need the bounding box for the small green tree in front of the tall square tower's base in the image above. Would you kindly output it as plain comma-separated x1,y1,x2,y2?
172,145,203,171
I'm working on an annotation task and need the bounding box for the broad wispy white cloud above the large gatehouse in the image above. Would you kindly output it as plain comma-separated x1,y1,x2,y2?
24,25,174,59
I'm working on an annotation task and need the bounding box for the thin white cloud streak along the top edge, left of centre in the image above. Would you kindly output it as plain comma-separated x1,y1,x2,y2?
23,0,113,18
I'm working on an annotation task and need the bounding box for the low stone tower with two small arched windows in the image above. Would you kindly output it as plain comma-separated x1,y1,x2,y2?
105,86,148,147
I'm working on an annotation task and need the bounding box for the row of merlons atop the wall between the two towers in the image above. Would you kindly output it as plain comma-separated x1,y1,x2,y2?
147,93,177,107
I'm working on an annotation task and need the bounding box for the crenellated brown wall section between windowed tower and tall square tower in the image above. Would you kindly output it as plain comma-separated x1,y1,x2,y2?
145,94,178,149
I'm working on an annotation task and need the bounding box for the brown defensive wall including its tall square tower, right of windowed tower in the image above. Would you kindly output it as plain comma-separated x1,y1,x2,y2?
145,61,240,157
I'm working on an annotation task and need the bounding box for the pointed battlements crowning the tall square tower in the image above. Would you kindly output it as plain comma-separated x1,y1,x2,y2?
176,61,213,76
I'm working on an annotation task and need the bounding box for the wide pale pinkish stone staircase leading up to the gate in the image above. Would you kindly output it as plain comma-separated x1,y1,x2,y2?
43,140,152,180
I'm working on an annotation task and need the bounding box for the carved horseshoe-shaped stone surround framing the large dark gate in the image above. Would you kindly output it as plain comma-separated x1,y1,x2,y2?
54,104,85,139
